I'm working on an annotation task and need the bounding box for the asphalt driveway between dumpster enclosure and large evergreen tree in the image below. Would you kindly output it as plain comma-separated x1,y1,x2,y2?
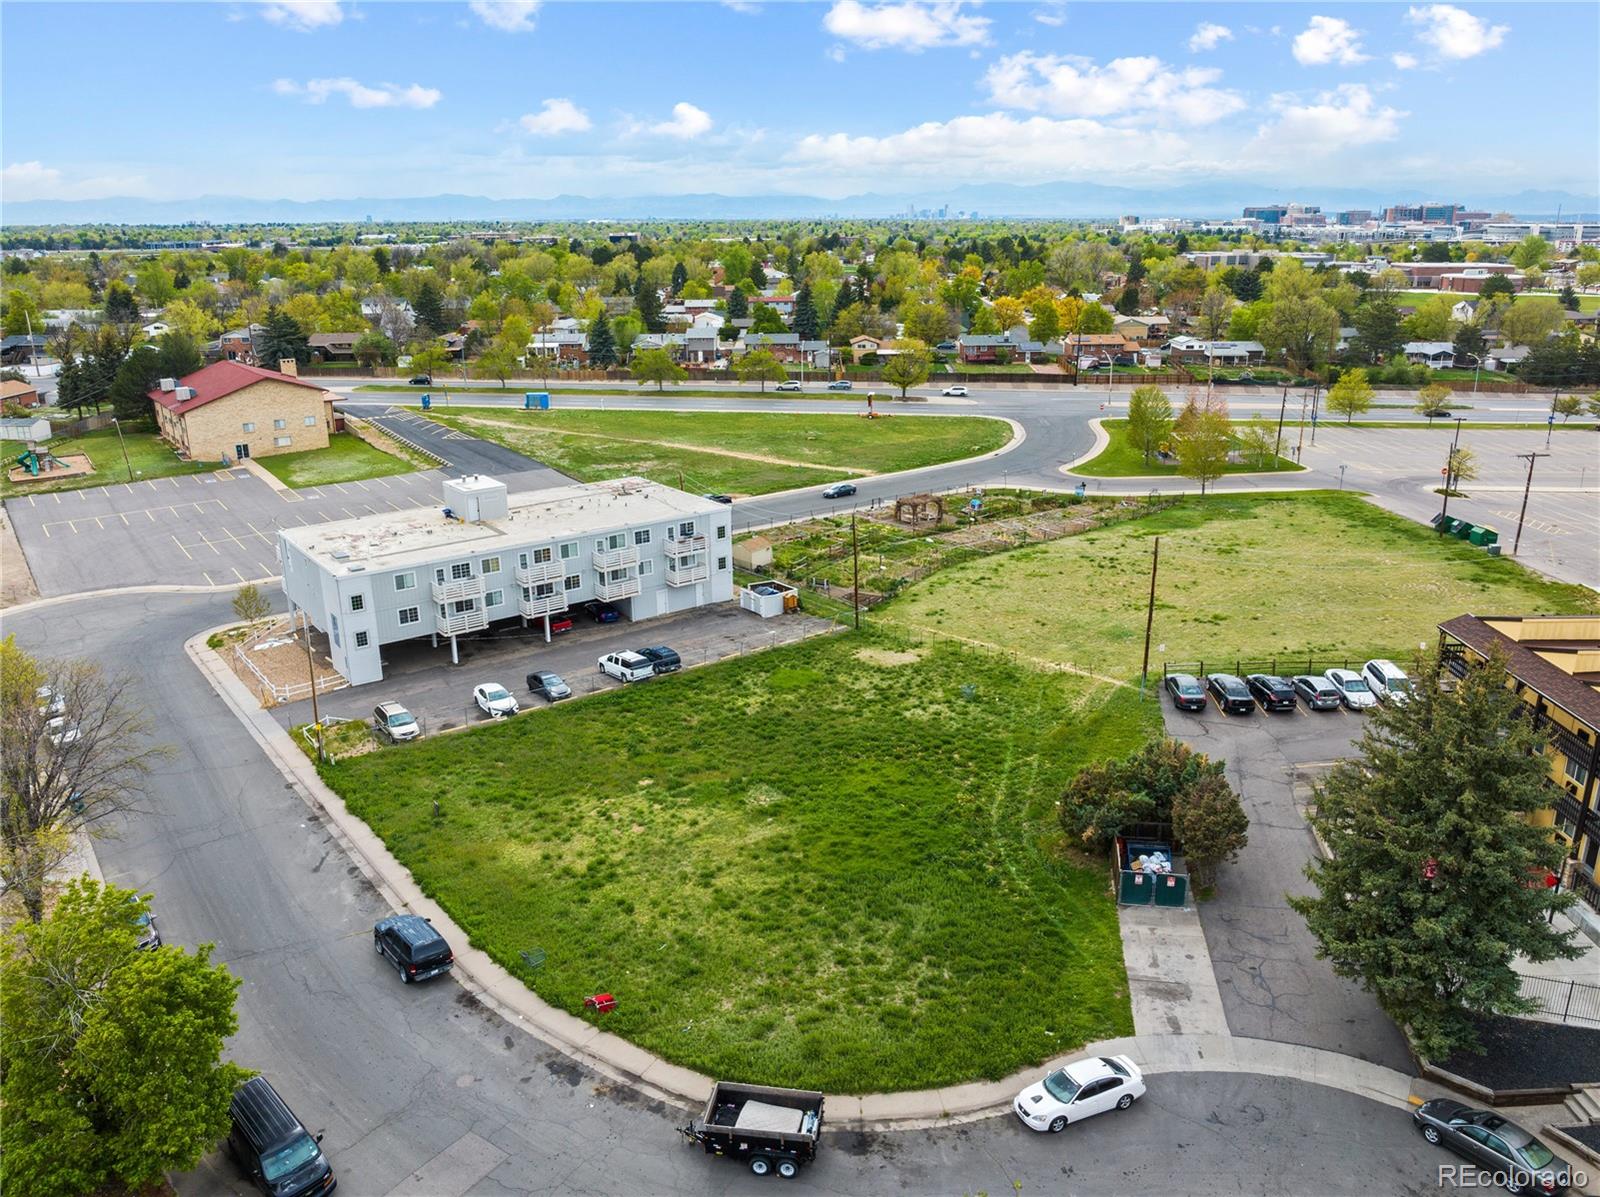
1162,678,1411,1071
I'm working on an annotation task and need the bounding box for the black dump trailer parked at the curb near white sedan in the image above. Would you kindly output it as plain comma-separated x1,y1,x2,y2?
680,1080,822,1179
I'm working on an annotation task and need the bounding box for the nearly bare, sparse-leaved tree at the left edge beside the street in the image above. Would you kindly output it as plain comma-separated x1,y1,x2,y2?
0,637,166,922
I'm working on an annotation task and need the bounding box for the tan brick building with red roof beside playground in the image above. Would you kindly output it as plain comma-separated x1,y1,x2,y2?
149,362,333,461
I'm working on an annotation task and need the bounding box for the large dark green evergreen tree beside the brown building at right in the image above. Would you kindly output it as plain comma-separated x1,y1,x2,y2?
1290,655,1576,1059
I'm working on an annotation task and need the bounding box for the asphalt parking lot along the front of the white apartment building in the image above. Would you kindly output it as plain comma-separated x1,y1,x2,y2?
272,603,835,735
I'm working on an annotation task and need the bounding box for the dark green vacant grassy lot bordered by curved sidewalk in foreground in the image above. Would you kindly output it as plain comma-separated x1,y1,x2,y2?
325,634,1157,1093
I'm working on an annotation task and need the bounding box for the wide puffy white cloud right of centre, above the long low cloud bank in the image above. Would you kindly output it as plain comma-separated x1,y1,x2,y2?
984,51,1245,125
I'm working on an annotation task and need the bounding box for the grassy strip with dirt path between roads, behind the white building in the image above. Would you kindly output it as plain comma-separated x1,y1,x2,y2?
429,408,1011,494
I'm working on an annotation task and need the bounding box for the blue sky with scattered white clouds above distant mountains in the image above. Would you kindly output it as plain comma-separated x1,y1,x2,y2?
0,0,1600,202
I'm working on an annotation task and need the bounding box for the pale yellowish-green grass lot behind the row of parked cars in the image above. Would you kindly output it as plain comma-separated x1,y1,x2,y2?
875,493,1600,677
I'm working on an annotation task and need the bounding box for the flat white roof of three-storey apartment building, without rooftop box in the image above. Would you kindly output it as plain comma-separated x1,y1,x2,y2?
280,477,726,574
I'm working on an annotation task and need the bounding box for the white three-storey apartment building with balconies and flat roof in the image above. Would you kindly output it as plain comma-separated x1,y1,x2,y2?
278,475,733,685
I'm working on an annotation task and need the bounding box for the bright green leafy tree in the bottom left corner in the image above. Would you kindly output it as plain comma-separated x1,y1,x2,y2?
0,877,248,1197
